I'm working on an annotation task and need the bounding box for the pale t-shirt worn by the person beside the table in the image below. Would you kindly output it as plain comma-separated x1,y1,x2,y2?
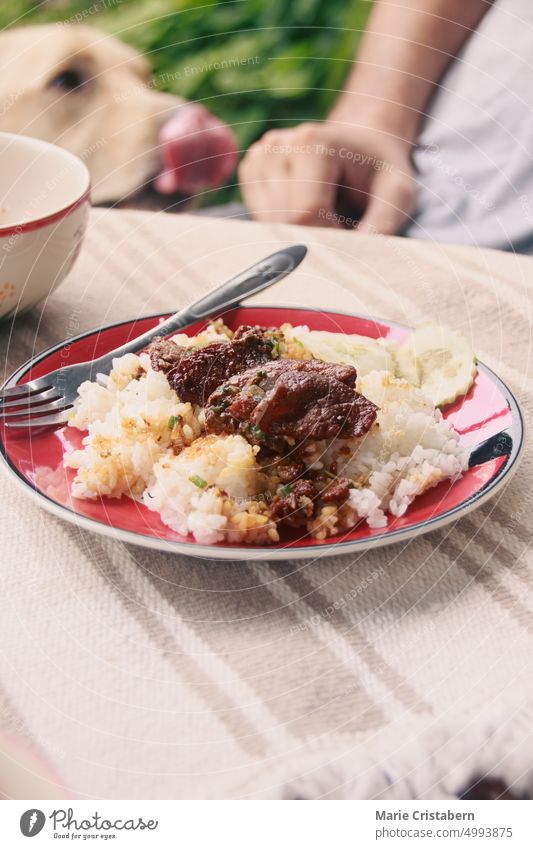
406,0,533,253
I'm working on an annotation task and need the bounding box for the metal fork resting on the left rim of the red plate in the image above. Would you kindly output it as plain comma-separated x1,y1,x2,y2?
0,245,307,428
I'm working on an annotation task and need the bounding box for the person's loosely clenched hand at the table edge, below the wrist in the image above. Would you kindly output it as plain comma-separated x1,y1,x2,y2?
239,121,415,234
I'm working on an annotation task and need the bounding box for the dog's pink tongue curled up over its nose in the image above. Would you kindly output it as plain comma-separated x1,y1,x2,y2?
154,103,237,194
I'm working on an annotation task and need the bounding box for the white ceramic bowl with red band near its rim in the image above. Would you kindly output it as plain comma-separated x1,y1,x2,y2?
0,133,90,318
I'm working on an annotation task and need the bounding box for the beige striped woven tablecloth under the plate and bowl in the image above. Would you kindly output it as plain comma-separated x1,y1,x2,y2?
0,211,533,798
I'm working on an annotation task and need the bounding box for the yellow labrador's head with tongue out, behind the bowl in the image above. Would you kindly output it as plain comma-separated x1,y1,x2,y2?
0,24,237,205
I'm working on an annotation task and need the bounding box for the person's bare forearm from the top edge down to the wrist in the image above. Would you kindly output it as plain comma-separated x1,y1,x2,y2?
330,0,492,143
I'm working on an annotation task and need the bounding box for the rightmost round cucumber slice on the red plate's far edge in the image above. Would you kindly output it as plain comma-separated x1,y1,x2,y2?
394,324,477,407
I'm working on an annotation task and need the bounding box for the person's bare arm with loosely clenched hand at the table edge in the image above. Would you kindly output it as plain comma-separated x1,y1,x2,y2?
239,0,491,233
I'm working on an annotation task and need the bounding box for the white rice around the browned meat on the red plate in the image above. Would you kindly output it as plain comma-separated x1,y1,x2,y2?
64,325,468,544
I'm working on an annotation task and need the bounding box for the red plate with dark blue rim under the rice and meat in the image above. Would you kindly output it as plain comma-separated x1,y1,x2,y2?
0,306,524,560
